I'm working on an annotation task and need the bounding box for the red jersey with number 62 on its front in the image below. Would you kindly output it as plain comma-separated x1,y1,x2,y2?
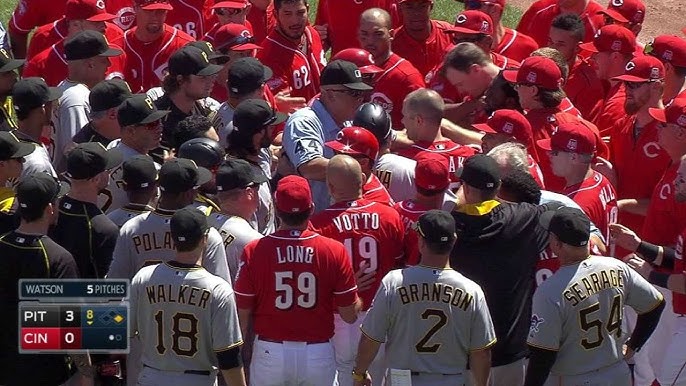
257,26,326,100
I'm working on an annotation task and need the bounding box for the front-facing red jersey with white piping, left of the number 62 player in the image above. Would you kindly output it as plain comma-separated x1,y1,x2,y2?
113,24,193,93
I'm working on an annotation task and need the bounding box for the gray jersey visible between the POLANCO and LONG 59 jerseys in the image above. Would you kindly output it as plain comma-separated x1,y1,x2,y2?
208,213,264,279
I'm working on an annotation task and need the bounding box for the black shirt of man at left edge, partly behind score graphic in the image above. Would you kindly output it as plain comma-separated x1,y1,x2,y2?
0,231,78,386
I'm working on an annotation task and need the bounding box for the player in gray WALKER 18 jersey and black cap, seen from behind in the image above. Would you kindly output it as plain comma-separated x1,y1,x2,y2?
130,208,245,386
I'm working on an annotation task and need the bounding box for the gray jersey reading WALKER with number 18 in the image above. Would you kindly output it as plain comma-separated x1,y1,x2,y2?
130,263,243,372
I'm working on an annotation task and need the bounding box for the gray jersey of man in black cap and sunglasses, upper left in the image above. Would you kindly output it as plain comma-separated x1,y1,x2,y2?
51,79,91,173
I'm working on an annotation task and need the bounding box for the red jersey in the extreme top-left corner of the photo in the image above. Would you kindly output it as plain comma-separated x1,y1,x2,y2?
7,0,66,35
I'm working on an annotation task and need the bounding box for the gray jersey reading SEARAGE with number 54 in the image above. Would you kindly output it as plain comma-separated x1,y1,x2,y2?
527,256,662,375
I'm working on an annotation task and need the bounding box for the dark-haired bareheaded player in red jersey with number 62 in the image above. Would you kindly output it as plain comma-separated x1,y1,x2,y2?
257,0,326,100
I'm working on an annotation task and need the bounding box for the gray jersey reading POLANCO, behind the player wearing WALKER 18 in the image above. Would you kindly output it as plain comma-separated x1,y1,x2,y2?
107,208,231,283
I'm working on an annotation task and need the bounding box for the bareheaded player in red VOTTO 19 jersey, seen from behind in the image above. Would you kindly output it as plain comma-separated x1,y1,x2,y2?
310,155,404,385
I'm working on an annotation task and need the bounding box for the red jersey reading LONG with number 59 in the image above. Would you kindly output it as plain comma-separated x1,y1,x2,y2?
234,230,357,342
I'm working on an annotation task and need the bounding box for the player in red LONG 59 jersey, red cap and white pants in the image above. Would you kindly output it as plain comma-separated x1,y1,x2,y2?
235,175,362,386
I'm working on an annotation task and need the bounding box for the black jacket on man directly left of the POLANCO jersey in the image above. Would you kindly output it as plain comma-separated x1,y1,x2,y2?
50,196,119,278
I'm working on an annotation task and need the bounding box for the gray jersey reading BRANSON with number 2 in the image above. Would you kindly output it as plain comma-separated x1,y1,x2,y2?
361,265,496,374
